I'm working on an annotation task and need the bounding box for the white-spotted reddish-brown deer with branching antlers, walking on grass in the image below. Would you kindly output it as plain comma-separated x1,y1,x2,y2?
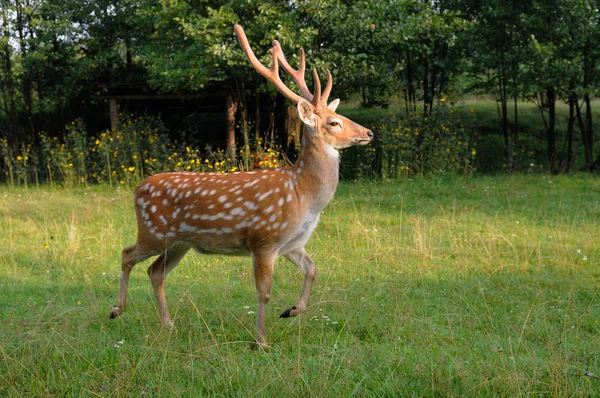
110,25,373,348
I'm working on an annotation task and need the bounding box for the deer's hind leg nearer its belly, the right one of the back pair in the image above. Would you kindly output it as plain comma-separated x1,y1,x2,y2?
148,245,190,327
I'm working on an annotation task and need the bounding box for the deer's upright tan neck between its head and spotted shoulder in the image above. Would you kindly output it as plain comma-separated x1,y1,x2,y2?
292,129,339,212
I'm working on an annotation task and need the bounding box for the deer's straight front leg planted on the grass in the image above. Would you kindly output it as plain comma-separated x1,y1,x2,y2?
252,253,277,348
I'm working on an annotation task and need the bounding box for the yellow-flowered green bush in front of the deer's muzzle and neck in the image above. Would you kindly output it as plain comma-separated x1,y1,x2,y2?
341,102,477,179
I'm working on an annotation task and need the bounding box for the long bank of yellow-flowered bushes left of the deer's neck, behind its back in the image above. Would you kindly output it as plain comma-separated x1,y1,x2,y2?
0,115,284,187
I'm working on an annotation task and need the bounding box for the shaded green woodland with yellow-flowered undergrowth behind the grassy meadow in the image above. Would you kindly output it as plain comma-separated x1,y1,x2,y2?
0,0,600,182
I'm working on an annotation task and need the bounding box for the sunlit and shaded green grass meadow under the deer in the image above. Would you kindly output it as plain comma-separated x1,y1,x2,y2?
0,175,600,397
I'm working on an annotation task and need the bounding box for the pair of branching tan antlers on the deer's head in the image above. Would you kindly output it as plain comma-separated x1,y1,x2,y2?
235,25,332,107
